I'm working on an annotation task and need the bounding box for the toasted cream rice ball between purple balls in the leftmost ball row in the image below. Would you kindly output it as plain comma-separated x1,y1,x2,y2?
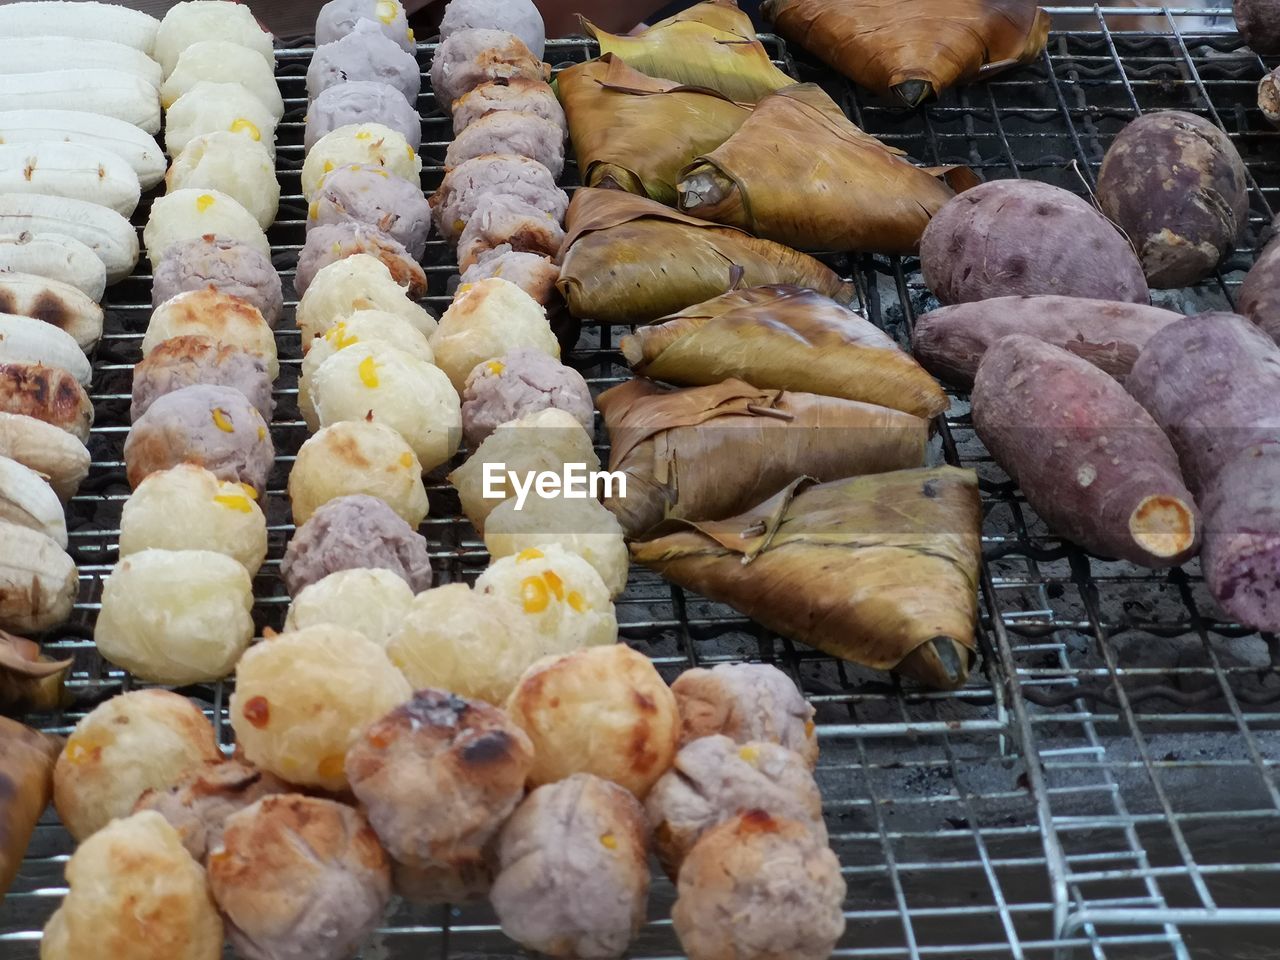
142,288,280,380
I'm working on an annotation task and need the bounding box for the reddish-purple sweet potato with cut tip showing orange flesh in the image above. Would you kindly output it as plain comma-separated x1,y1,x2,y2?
973,335,1199,567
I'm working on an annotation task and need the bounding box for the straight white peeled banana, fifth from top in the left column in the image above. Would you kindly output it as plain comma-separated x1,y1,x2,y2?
0,141,142,216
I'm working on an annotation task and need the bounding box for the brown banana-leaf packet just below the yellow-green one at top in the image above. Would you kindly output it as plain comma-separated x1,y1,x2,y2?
556,54,751,205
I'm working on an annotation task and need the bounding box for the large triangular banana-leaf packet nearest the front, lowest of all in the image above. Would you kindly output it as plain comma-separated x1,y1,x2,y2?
631,467,982,690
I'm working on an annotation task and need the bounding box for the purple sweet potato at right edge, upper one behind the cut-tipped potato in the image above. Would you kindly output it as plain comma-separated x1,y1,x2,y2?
1125,314,1280,495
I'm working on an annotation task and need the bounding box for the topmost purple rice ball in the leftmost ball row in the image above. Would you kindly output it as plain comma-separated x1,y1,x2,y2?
151,236,284,329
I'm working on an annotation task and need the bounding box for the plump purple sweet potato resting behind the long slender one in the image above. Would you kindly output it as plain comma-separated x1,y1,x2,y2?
920,180,1151,303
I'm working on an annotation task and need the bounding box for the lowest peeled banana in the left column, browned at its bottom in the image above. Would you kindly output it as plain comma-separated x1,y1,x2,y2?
0,519,79,634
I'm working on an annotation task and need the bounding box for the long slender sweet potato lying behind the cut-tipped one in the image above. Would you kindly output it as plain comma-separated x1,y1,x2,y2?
911,296,1181,389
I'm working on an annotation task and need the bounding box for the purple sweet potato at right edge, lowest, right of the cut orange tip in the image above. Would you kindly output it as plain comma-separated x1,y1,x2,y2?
1202,444,1280,631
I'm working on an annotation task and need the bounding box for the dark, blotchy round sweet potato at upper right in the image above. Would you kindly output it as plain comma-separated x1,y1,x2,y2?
1098,110,1249,288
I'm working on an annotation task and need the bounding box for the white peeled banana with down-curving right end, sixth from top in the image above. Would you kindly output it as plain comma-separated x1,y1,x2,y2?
0,193,138,283
